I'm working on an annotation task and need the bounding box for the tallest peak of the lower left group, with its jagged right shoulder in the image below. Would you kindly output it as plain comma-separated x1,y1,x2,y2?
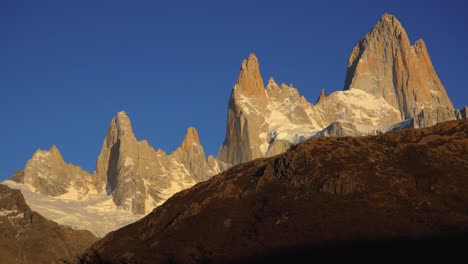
95,112,196,214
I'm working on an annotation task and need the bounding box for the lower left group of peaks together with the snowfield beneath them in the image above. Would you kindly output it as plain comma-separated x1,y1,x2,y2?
4,112,221,233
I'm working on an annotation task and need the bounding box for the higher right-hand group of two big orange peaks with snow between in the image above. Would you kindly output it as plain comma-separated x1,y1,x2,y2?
218,14,460,165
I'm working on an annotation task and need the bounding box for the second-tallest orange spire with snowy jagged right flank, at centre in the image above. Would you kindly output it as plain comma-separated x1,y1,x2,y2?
218,58,321,166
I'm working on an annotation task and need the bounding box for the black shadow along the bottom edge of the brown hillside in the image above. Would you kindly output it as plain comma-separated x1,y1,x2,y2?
63,233,468,264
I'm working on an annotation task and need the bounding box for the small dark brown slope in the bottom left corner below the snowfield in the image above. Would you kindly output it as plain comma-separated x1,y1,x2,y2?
0,184,96,263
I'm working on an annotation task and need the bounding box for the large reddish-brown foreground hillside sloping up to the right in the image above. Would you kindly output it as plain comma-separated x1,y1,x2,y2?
87,119,468,263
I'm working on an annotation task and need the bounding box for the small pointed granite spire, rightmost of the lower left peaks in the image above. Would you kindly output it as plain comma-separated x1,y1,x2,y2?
171,127,214,182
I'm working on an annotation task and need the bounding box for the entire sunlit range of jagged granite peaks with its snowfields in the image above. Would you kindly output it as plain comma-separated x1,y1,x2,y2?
4,14,467,237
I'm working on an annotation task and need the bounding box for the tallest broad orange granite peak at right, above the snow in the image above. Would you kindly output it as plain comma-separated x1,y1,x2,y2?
344,14,454,119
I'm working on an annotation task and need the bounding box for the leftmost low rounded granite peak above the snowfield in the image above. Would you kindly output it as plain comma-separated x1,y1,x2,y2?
11,145,96,199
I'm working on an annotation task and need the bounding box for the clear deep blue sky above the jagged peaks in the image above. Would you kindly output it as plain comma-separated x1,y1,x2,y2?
0,0,468,180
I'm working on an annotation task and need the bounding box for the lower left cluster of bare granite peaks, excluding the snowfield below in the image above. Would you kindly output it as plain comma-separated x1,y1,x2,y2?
7,112,218,218
